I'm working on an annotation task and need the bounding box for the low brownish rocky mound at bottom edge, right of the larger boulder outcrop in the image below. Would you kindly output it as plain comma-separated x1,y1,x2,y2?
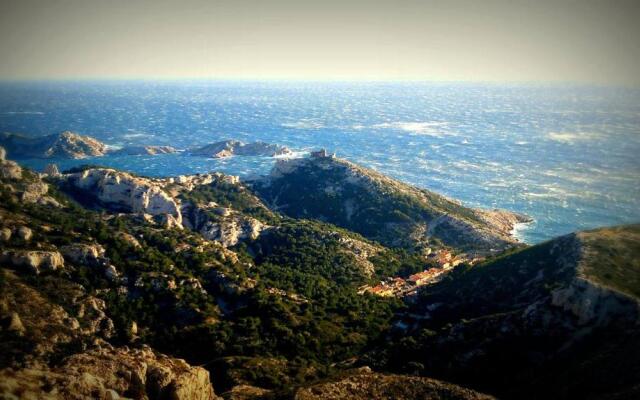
295,367,494,400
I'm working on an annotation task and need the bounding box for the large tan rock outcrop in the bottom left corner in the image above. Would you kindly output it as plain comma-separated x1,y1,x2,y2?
0,347,218,400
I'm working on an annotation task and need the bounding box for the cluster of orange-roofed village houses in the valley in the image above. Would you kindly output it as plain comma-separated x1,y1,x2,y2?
358,250,482,298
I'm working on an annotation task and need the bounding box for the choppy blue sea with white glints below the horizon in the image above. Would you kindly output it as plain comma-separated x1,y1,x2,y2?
0,81,640,243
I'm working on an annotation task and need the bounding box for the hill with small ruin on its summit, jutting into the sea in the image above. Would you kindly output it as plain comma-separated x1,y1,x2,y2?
254,155,528,255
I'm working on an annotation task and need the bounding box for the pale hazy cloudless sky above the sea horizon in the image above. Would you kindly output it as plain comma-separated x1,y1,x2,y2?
0,0,640,85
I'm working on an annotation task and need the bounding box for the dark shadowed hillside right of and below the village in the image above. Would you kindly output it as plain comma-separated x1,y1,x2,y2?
385,225,640,398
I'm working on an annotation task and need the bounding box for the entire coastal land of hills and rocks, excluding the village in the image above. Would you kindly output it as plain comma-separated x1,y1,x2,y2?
0,148,640,400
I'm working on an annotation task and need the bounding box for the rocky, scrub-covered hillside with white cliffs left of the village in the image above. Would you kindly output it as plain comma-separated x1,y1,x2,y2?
0,152,450,399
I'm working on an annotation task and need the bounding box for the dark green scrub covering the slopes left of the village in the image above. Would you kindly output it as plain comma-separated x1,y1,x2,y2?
0,166,412,390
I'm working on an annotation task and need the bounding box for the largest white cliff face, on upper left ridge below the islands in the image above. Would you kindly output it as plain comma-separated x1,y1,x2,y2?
65,169,182,224
